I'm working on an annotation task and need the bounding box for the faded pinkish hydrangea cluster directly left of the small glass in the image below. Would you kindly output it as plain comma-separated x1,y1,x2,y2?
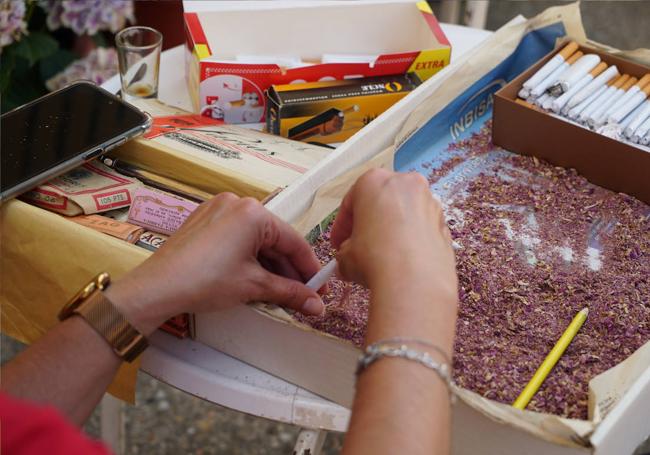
45,47,118,91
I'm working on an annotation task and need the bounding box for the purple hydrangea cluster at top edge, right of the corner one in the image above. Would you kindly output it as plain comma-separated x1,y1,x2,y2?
41,0,134,35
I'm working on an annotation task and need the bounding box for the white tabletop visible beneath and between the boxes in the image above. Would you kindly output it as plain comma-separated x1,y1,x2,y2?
103,24,492,431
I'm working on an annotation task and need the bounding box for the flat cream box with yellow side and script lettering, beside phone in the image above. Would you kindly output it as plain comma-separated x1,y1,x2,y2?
111,100,331,200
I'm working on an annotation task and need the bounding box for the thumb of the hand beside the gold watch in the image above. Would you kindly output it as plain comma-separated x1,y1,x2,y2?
253,270,325,316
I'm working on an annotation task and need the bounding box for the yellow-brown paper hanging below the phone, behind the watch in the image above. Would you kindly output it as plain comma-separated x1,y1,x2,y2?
0,200,151,403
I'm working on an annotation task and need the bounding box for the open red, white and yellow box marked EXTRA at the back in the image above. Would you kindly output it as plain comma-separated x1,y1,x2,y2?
184,1,451,123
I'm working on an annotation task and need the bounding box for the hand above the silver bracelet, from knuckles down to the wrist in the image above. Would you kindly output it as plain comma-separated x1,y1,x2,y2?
331,169,458,301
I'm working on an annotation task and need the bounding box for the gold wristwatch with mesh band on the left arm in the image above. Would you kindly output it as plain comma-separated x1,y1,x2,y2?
59,272,149,362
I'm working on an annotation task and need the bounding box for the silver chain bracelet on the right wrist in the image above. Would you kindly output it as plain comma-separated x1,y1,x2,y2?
356,339,454,402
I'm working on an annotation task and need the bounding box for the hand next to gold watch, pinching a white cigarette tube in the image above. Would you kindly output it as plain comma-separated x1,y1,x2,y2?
107,193,323,335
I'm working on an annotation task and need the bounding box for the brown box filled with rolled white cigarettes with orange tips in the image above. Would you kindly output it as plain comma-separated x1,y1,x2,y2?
493,42,650,201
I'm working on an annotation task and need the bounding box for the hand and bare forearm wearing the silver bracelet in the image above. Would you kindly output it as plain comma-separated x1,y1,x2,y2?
331,170,458,454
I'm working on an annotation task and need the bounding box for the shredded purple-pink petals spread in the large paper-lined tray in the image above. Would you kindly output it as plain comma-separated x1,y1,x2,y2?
295,122,650,419
